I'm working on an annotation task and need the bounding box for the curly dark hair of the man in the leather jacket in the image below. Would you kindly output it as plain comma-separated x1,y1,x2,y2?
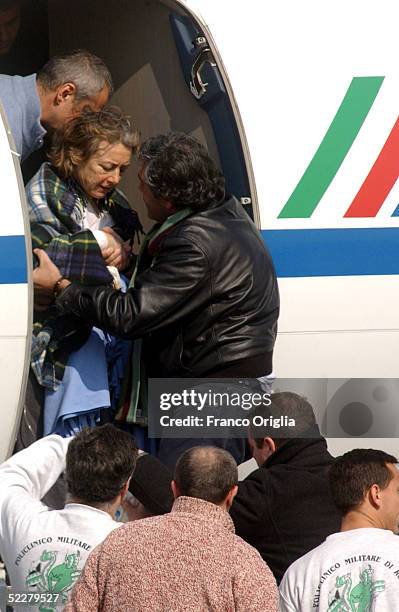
139,132,225,210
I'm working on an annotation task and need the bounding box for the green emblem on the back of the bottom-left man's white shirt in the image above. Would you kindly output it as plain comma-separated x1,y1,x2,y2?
25,550,82,612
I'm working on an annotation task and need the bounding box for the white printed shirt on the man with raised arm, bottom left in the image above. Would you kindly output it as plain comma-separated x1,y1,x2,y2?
0,435,120,611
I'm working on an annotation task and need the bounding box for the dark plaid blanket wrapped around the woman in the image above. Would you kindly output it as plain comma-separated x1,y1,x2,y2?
26,163,142,389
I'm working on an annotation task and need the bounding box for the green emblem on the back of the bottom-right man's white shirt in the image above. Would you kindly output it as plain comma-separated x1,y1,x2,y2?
327,565,385,612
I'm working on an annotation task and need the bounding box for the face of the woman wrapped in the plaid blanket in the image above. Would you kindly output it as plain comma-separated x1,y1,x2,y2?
75,141,132,200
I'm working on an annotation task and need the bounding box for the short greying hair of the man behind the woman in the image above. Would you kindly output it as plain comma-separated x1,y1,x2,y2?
37,49,113,101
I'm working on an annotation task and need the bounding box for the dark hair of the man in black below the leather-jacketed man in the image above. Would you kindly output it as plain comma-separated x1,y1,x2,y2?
248,391,320,448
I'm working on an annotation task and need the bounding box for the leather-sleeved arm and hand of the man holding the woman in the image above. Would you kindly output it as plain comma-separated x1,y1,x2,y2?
38,236,210,339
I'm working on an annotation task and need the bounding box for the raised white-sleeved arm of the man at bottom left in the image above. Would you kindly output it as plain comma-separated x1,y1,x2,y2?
0,435,71,536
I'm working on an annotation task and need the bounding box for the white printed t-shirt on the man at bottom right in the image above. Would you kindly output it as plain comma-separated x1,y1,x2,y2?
280,528,399,612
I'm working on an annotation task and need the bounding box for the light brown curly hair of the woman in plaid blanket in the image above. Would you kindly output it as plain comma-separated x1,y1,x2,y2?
48,106,139,179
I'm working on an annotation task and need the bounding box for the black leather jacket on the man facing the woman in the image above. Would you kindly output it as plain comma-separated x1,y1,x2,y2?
56,197,279,377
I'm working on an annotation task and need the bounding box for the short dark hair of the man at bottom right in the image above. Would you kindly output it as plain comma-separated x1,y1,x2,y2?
328,448,398,515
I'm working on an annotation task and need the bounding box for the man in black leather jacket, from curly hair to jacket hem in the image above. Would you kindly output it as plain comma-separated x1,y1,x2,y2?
34,133,279,377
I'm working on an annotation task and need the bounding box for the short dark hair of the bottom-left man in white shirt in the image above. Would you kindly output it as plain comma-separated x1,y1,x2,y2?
66,423,137,504
